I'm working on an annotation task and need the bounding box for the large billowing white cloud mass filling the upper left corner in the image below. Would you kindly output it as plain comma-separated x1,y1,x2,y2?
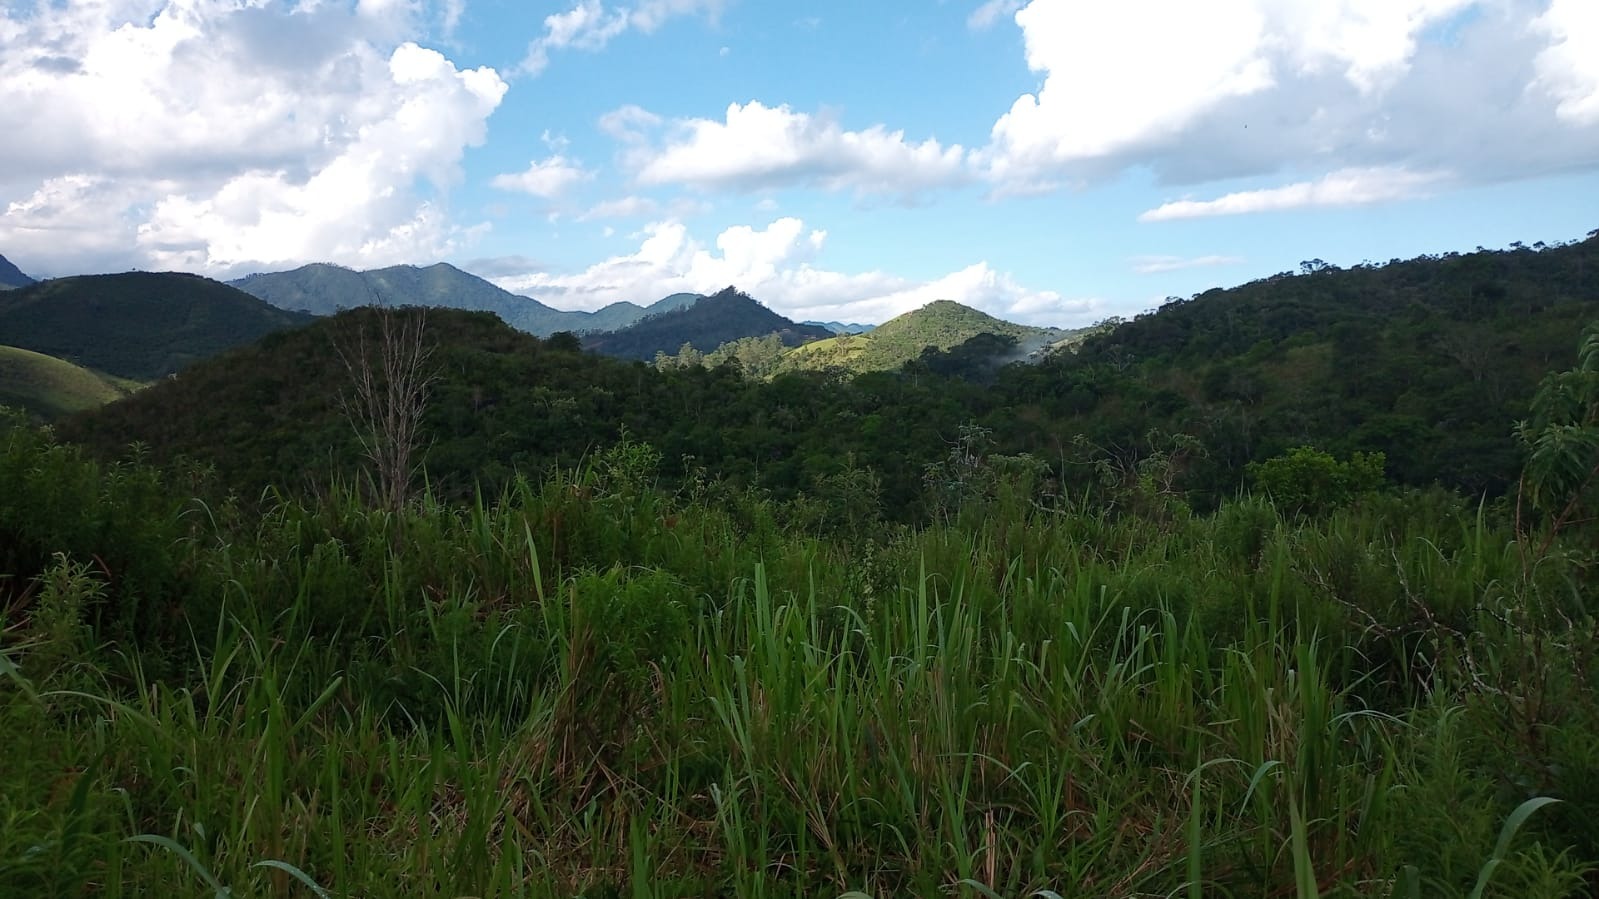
0,0,505,275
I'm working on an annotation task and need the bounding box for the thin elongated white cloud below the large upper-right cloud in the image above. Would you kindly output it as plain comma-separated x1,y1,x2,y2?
1138,170,1445,222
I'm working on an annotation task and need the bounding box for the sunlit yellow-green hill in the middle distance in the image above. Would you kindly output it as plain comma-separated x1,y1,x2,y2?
779,299,1076,373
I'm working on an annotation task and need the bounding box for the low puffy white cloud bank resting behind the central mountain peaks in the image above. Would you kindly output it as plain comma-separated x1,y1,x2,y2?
482,218,1099,325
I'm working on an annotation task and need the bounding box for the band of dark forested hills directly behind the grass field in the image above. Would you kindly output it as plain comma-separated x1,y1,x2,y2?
61,230,1599,520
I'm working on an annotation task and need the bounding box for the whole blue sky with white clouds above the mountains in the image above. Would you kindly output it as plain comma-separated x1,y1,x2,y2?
0,0,1599,326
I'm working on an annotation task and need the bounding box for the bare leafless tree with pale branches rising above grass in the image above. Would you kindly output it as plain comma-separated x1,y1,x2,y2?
334,306,438,512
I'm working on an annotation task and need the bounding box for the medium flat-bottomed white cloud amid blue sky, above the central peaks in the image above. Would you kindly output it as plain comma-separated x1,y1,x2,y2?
617,101,967,195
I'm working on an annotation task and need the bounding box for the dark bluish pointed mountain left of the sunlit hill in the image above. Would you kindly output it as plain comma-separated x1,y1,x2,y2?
584,288,831,360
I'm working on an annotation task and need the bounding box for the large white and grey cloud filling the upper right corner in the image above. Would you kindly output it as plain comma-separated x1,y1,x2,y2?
972,0,1599,198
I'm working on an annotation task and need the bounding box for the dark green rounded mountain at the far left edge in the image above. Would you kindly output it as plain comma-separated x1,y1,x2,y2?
0,272,310,381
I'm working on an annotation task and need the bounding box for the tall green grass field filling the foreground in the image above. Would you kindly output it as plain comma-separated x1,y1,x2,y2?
0,419,1599,899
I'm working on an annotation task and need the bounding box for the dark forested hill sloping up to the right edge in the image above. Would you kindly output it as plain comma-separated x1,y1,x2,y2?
1007,232,1599,493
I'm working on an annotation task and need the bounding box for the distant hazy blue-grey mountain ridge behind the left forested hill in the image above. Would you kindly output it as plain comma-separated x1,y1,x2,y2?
229,262,699,338
